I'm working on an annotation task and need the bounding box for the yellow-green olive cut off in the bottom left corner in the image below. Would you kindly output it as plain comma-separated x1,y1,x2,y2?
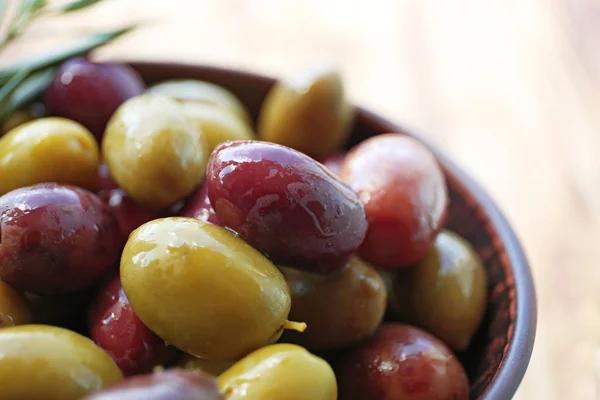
0,325,123,400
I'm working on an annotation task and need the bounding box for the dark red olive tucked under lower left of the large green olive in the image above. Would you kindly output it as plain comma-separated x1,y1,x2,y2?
88,274,179,375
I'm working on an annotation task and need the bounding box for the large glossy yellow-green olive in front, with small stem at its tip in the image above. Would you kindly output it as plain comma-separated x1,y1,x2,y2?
121,217,290,361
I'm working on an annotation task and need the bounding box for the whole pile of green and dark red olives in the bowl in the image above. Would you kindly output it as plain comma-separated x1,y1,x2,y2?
0,58,487,400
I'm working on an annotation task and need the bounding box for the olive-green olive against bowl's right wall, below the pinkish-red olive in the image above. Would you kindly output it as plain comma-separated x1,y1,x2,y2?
386,231,487,351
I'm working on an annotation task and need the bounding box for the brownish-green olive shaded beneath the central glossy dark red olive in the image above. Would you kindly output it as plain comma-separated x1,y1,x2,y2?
280,257,387,350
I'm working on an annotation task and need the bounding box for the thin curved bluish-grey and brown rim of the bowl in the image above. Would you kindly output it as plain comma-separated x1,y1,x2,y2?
124,60,537,400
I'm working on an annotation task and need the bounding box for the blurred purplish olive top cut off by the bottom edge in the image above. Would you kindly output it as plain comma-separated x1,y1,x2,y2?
82,370,223,400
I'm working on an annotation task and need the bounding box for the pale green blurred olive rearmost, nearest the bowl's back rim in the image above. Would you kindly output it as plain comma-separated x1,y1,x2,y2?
146,79,252,126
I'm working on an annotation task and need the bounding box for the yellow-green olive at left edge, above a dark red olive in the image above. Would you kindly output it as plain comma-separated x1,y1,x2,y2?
0,118,100,195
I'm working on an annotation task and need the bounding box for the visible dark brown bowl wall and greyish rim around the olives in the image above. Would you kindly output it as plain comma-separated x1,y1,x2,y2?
125,63,535,400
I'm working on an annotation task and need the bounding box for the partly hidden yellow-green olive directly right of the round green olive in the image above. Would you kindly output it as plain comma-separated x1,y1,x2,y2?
182,102,255,153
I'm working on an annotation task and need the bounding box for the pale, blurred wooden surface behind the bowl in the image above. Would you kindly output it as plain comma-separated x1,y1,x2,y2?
0,0,600,400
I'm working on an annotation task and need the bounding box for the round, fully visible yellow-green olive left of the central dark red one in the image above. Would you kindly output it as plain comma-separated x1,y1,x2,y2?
102,95,207,208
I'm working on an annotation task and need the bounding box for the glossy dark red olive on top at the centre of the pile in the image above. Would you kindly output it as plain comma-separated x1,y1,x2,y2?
206,141,367,272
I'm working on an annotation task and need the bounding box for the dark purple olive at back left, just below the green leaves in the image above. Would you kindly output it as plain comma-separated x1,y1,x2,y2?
44,57,145,139
